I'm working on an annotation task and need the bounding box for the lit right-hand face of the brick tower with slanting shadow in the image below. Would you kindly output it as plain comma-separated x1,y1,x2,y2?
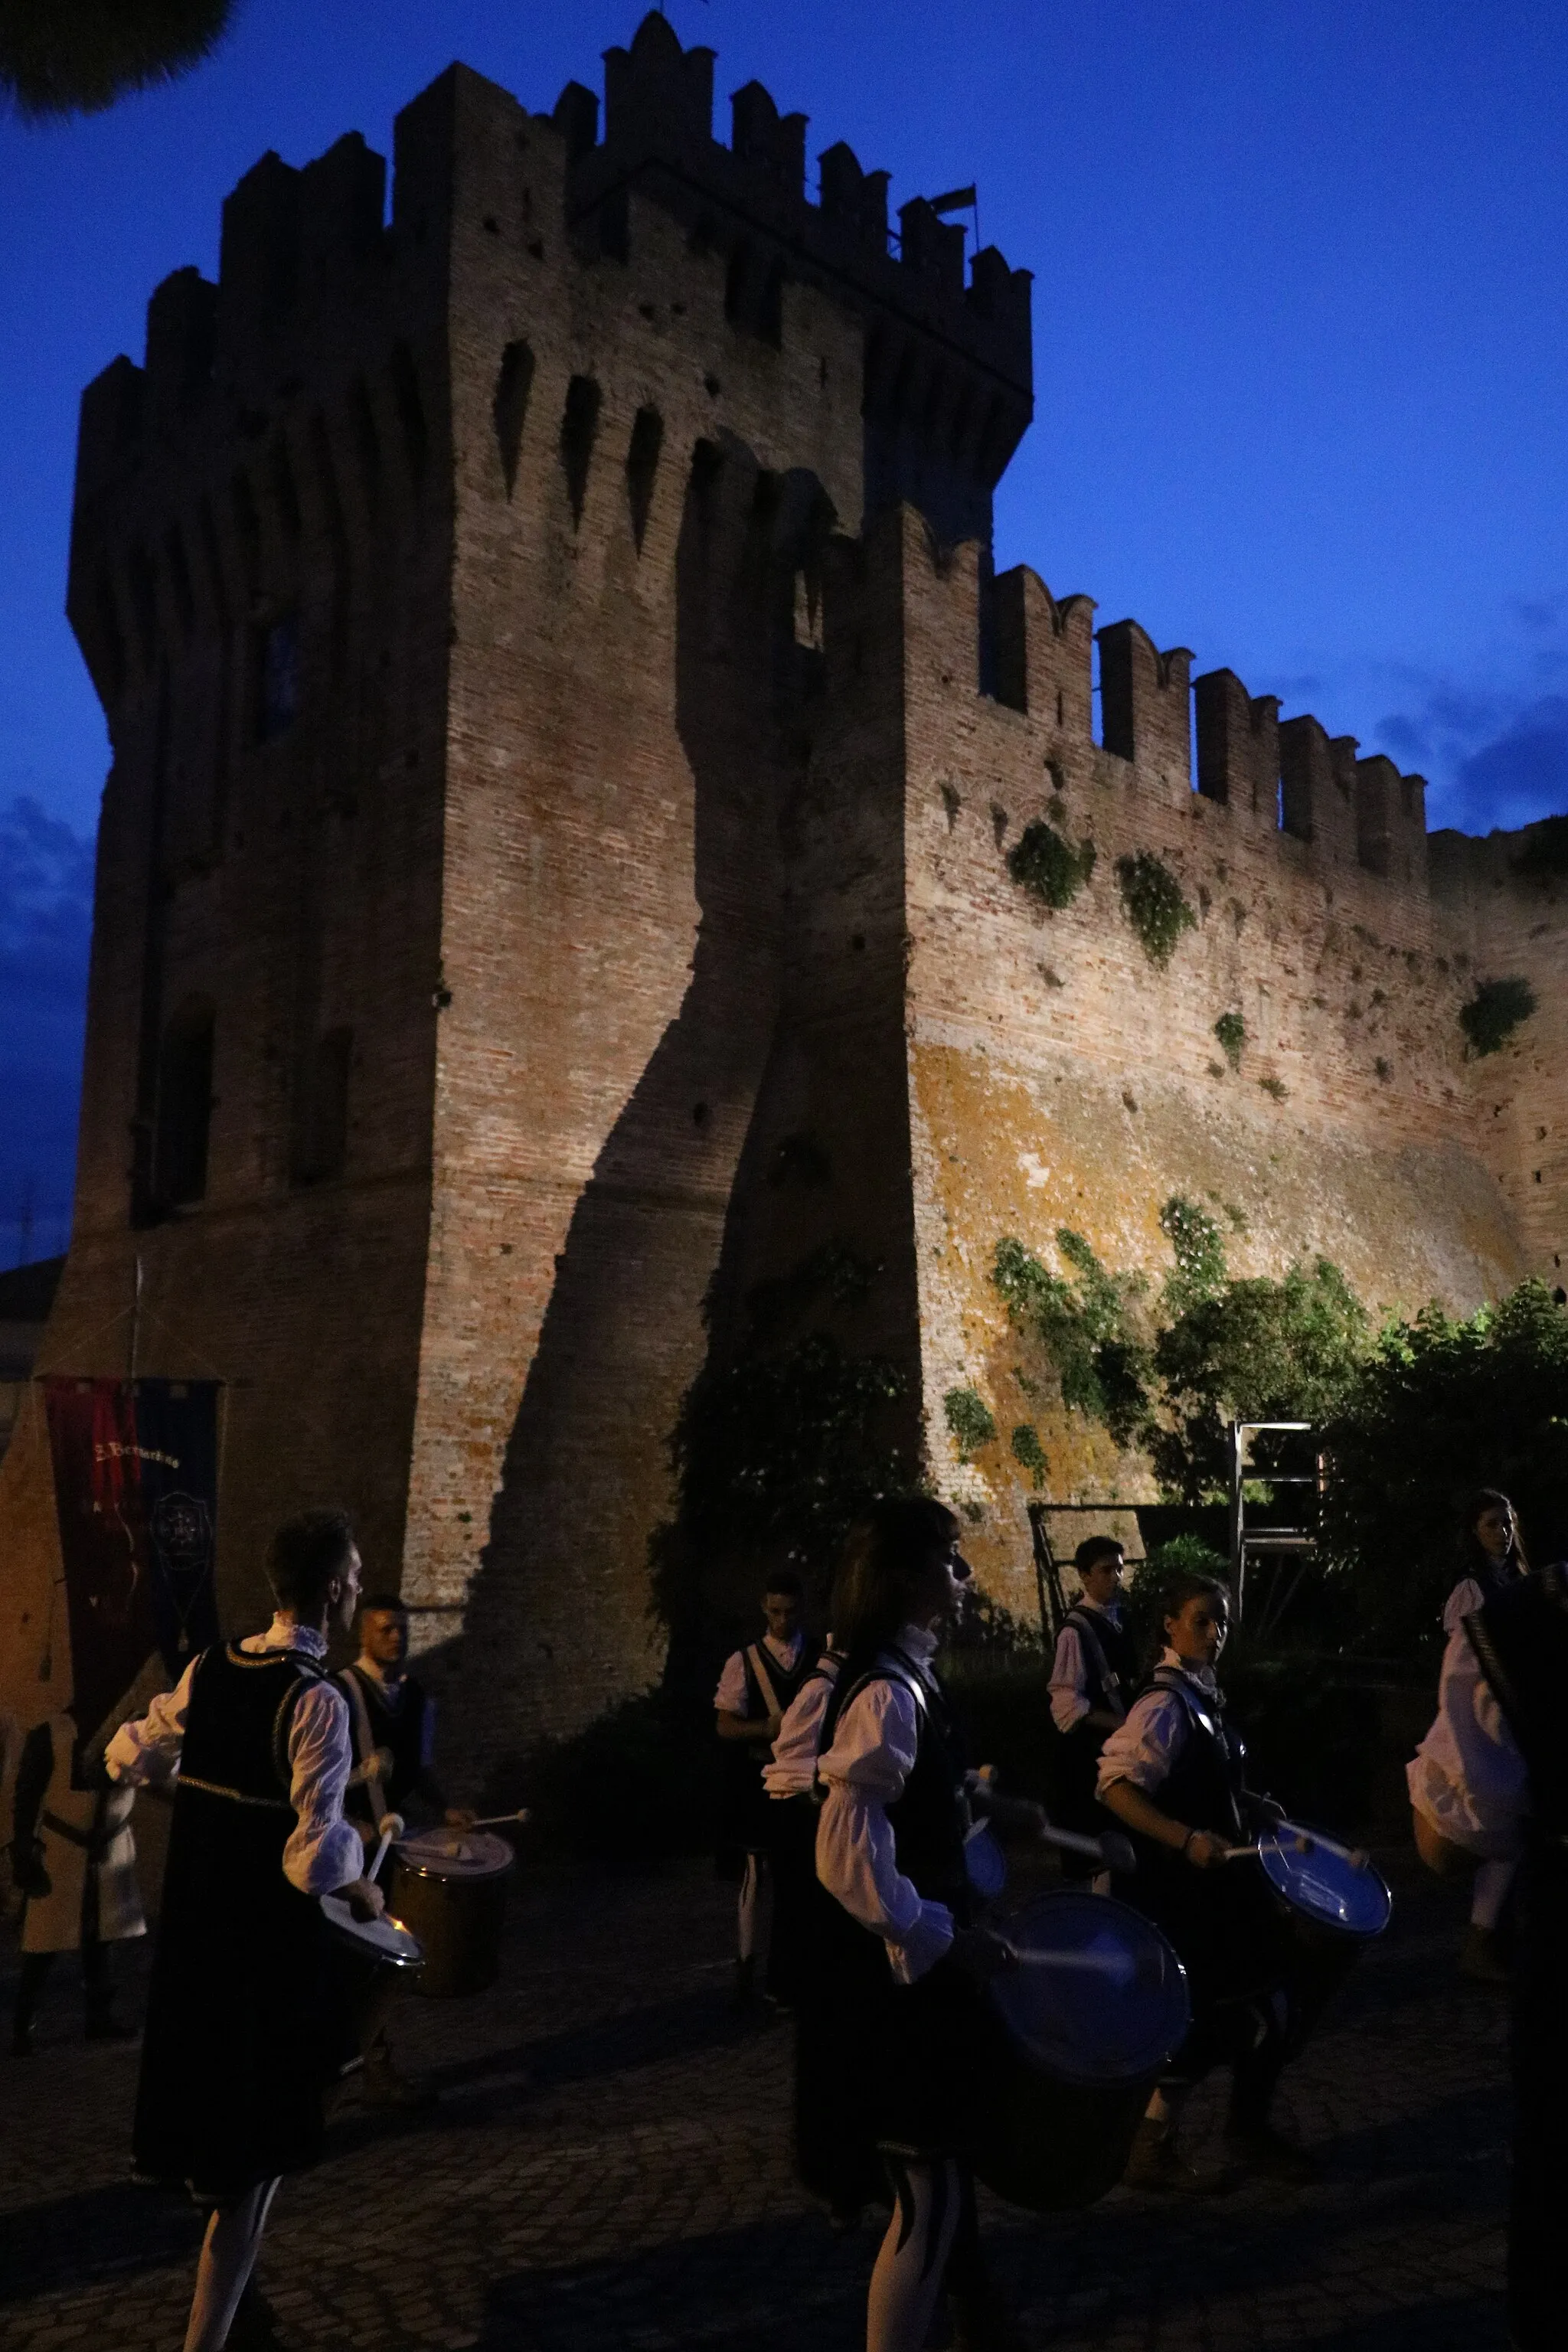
400,73,884,1753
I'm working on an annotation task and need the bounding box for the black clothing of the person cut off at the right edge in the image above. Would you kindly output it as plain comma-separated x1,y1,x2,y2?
1465,1562,1568,2352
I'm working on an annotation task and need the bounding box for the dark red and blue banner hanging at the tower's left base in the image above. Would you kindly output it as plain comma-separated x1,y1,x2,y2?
42,1378,219,1745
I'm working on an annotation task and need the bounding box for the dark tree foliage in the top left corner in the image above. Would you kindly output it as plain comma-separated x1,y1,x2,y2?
0,0,235,122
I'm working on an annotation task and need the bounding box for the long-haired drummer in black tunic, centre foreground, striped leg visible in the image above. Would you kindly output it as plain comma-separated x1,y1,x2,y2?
797,1501,1013,2352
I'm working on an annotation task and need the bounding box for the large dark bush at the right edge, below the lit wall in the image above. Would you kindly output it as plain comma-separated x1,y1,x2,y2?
1324,1282,1568,1654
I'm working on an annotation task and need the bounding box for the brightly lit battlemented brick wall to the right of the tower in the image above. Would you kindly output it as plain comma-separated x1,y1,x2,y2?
900,513,1549,1613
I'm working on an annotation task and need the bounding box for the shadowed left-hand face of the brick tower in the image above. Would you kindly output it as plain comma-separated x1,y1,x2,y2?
0,139,452,1712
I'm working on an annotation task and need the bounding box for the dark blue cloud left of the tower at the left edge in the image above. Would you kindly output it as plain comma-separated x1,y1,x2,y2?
0,792,92,1266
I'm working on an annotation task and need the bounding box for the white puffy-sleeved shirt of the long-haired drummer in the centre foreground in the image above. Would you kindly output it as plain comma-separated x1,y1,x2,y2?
815,1630,952,1985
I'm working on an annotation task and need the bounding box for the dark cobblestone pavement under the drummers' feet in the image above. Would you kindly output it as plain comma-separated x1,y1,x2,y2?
0,1856,1507,2352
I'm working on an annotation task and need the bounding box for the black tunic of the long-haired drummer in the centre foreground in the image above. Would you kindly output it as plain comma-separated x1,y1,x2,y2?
797,1658,988,2207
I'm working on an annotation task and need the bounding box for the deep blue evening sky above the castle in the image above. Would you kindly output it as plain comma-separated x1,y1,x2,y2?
0,0,1568,1266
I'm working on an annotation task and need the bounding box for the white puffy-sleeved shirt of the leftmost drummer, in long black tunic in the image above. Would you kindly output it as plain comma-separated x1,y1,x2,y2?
103,1619,364,1896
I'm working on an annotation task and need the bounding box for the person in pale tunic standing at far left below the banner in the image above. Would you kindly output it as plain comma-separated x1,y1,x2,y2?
11,1714,145,2058
